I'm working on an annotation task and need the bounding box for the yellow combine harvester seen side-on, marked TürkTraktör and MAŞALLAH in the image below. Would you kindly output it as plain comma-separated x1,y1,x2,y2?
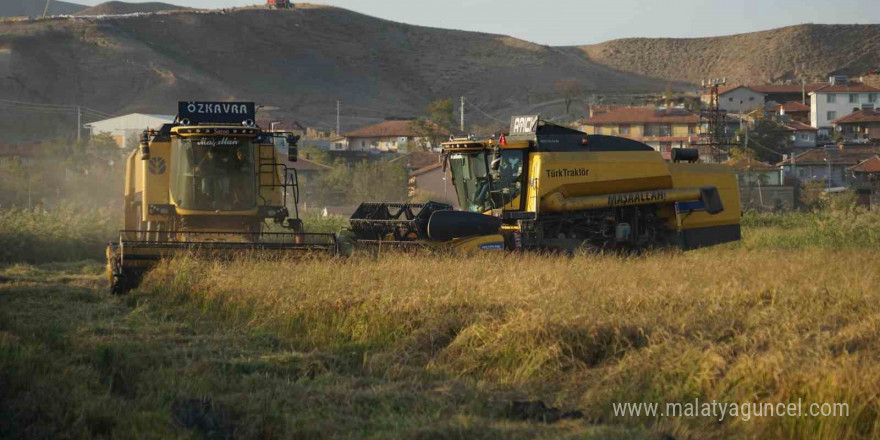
350,115,740,252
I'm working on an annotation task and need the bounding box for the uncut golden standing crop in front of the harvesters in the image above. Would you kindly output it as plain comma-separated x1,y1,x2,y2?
132,249,880,439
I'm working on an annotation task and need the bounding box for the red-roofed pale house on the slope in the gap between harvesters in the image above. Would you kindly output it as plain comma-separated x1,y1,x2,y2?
343,118,449,154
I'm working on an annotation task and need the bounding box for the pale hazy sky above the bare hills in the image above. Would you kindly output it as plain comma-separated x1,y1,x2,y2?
68,0,880,46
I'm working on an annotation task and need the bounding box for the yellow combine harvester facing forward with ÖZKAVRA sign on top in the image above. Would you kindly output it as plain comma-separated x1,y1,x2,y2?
107,102,337,293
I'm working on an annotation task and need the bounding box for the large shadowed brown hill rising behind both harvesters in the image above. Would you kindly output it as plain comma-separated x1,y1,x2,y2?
0,5,667,140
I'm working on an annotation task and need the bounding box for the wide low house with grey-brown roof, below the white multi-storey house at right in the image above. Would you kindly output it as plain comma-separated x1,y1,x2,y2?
776,144,877,186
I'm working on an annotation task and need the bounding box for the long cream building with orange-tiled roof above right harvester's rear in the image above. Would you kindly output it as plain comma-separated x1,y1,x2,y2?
580,107,700,153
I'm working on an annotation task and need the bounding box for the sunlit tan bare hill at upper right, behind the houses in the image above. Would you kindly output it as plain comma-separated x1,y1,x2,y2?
575,24,880,83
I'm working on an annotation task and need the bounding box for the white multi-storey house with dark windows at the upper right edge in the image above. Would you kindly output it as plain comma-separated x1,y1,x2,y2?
810,76,880,134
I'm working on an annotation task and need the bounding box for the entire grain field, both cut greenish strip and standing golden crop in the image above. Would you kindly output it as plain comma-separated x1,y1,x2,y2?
0,211,880,439
